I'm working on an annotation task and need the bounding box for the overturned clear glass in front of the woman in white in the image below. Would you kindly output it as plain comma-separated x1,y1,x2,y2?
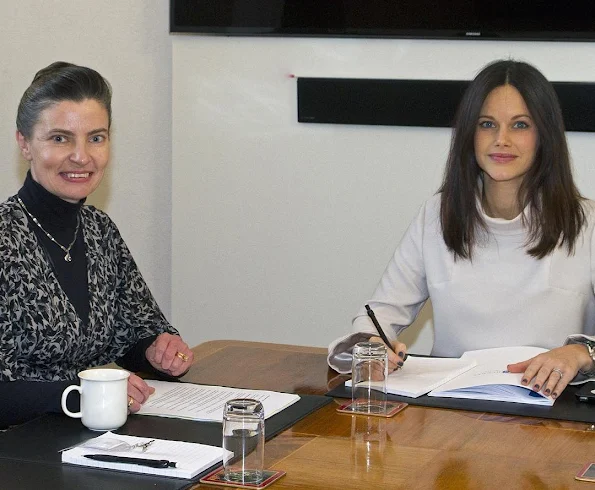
351,342,388,414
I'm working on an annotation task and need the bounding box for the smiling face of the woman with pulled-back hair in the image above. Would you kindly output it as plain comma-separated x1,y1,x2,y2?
16,99,109,203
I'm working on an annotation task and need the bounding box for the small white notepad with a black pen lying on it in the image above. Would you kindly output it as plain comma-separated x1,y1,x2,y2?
62,432,225,478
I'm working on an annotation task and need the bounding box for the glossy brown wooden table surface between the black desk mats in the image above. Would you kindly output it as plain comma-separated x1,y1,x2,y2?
184,341,595,490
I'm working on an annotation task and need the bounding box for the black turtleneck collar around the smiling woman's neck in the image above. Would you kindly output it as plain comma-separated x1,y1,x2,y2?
18,170,85,229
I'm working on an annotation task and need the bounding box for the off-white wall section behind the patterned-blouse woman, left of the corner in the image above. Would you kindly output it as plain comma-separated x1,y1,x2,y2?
0,0,171,315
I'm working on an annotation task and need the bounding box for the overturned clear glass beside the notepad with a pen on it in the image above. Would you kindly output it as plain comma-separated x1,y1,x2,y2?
223,398,264,483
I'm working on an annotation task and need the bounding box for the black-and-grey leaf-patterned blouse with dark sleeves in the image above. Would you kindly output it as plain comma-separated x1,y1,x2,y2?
0,183,177,428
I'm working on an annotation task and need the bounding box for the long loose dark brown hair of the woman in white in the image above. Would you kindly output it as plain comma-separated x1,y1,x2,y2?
439,60,585,259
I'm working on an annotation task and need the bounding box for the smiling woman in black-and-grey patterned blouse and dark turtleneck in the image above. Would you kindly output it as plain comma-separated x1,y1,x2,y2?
0,62,193,428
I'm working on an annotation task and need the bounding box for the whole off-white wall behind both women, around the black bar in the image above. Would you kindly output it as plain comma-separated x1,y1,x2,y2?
0,0,595,351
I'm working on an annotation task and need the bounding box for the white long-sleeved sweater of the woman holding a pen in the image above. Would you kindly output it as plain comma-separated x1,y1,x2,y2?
328,195,595,372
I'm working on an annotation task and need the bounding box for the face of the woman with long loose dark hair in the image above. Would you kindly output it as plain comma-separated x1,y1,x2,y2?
475,85,538,190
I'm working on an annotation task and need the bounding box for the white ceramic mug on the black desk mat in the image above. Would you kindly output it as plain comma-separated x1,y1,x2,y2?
62,368,130,431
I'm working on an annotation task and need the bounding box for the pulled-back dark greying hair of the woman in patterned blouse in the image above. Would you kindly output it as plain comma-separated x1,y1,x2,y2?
17,61,112,138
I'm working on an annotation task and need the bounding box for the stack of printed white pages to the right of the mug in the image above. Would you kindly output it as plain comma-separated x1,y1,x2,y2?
137,379,300,422
